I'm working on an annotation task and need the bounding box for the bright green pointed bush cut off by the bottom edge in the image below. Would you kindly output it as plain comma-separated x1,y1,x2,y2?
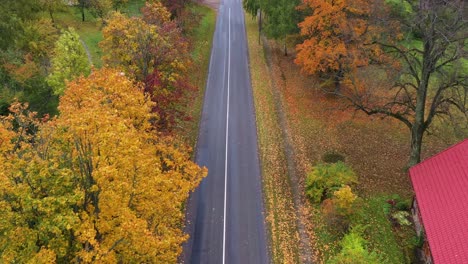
327,227,382,264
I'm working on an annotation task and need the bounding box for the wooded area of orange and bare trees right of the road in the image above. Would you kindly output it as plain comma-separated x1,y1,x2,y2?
244,0,468,166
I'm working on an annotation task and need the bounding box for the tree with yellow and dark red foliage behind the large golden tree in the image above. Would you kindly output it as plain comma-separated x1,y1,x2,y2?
100,2,193,130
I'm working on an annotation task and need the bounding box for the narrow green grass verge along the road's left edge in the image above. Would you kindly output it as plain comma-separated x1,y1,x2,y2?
182,3,216,146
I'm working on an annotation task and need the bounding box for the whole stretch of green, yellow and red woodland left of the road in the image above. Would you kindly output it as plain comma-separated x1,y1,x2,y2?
0,0,214,263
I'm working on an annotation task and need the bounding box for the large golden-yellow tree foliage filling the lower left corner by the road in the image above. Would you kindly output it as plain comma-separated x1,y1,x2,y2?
0,69,204,263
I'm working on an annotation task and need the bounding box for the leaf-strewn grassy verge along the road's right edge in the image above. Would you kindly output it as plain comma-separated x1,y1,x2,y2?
246,15,299,263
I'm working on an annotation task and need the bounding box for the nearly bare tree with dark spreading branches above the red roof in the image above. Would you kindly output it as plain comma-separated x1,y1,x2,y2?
343,0,468,166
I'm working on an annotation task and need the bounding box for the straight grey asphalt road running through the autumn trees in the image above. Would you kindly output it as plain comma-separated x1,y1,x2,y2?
181,0,270,264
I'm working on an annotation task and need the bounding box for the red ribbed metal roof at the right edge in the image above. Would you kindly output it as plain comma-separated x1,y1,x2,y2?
409,139,468,264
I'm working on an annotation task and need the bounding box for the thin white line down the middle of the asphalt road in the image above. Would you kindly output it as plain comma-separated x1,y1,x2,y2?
223,8,231,264
